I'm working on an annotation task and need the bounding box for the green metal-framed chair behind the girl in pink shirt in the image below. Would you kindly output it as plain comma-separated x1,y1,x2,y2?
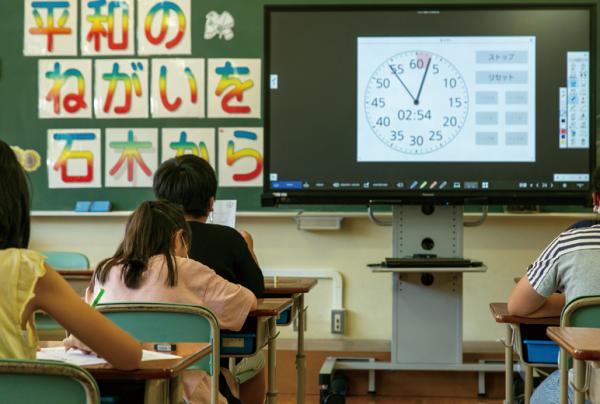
96,302,220,404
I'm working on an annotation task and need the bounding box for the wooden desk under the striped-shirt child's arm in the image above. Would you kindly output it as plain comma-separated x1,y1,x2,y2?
490,303,560,404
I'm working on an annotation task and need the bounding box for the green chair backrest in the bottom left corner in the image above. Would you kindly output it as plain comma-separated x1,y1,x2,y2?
0,359,100,404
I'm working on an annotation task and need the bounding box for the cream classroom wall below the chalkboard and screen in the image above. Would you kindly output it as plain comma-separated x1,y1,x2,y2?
31,214,581,341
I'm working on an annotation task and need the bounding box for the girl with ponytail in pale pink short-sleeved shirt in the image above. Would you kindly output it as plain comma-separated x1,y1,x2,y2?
86,201,257,403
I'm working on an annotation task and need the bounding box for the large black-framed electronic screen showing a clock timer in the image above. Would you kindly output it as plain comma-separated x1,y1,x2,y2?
263,2,596,205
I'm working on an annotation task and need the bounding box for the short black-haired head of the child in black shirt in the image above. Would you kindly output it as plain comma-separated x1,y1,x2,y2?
153,154,217,217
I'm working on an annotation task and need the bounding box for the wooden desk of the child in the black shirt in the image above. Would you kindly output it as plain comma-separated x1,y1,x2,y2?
264,277,318,404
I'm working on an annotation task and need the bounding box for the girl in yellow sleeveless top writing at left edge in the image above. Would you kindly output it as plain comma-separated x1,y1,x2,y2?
0,140,142,370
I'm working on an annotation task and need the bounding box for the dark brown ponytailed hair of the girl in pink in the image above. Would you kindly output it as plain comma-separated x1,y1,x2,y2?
95,201,191,289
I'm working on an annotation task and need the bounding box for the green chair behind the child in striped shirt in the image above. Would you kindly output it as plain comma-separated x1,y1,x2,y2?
559,295,600,404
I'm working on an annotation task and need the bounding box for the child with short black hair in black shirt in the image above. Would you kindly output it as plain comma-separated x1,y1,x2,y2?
153,155,266,404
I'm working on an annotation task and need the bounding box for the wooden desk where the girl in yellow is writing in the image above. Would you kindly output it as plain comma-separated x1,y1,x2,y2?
40,341,212,404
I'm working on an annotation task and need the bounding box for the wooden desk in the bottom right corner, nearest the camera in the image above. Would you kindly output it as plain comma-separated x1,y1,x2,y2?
547,327,600,404
